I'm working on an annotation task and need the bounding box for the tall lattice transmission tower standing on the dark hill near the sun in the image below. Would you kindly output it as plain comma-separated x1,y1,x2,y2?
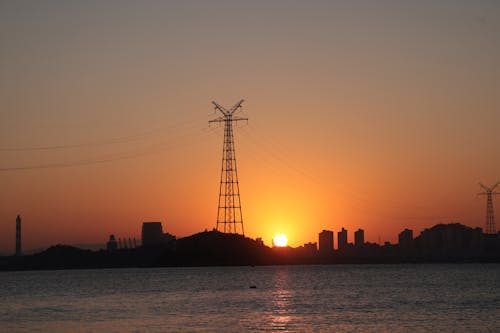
209,100,248,235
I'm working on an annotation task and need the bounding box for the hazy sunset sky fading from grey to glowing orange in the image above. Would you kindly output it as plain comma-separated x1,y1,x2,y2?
0,0,500,253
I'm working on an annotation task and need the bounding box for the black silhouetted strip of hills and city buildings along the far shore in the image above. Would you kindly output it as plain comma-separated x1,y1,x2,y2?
0,218,500,270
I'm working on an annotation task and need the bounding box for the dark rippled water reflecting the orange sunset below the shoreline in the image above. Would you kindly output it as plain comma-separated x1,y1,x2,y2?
0,264,500,332
